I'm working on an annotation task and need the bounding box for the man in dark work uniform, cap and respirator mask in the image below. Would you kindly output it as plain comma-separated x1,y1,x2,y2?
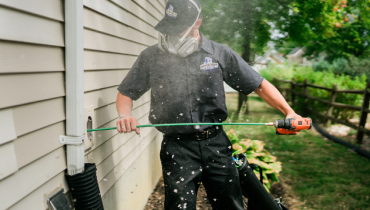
116,0,300,210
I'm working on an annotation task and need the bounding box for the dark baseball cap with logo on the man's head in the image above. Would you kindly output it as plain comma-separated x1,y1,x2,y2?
154,0,201,36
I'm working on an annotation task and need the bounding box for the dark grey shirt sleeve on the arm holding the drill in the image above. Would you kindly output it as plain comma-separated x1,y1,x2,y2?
223,49,264,95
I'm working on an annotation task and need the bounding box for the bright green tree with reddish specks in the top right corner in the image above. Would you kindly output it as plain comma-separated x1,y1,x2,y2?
274,0,370,62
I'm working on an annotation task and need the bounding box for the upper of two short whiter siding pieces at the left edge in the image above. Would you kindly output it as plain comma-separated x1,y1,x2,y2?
0,109,17,144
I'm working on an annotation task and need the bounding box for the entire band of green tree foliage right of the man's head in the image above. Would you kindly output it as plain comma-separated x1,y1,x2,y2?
201,0,370,61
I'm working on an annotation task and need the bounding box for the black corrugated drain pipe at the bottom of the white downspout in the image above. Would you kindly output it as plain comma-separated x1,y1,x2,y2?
66,163,104,210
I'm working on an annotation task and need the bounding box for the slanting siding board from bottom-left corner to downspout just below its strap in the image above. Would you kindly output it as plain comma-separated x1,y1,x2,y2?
0,147,66,209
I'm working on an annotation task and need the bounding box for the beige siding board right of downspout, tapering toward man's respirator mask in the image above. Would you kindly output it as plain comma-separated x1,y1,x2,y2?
84,8,158,46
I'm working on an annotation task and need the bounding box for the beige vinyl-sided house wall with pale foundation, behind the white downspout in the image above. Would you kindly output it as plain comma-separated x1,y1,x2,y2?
0,0,165,210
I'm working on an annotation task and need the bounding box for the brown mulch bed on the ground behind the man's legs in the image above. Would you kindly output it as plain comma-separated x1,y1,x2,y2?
144,177,299,210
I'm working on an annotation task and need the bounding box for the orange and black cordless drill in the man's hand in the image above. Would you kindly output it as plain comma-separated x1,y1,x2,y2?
266,118,312,135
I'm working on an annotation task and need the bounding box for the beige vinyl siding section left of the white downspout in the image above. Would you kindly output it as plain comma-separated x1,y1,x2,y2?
0,0,68,209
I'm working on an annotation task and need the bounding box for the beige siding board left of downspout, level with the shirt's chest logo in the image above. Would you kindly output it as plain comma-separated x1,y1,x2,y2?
0,41,64,74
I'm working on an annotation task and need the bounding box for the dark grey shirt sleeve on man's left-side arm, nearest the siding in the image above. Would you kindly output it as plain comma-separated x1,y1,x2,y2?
117,51,150,100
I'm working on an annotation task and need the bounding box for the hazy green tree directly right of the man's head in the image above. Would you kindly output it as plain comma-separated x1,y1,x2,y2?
201,0,285,109
